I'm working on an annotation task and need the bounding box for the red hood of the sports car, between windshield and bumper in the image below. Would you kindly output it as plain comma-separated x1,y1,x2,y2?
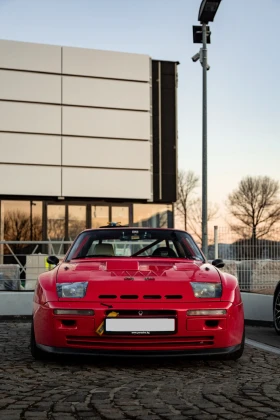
57,259,221,303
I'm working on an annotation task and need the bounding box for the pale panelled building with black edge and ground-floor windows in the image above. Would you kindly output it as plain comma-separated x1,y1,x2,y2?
0,40,178,240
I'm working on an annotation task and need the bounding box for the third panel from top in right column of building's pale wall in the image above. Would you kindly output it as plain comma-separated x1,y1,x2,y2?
62,107,150,140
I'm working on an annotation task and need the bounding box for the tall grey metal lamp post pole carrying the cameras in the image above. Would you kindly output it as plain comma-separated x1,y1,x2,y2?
202,23,208,258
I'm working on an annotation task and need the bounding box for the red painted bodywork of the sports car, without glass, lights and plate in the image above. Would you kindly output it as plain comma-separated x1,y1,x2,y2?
33,228,244,357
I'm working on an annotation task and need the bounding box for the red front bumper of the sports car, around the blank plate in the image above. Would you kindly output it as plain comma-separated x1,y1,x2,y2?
33,301,244,357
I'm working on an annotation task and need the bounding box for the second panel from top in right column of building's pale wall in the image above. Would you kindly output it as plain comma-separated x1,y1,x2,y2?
63,76,150,111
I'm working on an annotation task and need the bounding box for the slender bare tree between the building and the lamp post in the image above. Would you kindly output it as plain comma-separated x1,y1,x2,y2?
176,170,199,230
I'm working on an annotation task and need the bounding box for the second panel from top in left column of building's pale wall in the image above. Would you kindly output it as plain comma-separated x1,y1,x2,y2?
0,70,61,104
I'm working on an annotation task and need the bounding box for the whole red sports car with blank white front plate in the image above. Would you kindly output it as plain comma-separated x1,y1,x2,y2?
31,227,244,359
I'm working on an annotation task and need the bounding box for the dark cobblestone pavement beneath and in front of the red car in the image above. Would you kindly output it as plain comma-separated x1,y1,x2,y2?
0,322,280,420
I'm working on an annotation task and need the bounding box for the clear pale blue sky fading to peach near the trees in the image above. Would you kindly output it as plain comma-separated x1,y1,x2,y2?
0,0,280,225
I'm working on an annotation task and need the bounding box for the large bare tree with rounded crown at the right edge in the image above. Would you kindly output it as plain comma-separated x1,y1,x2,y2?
227,176,280,242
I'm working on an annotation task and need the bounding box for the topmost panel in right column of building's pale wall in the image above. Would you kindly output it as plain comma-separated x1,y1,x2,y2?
62,47,150,82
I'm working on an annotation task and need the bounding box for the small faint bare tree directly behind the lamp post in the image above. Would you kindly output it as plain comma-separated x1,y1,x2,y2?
190,198,219,243
